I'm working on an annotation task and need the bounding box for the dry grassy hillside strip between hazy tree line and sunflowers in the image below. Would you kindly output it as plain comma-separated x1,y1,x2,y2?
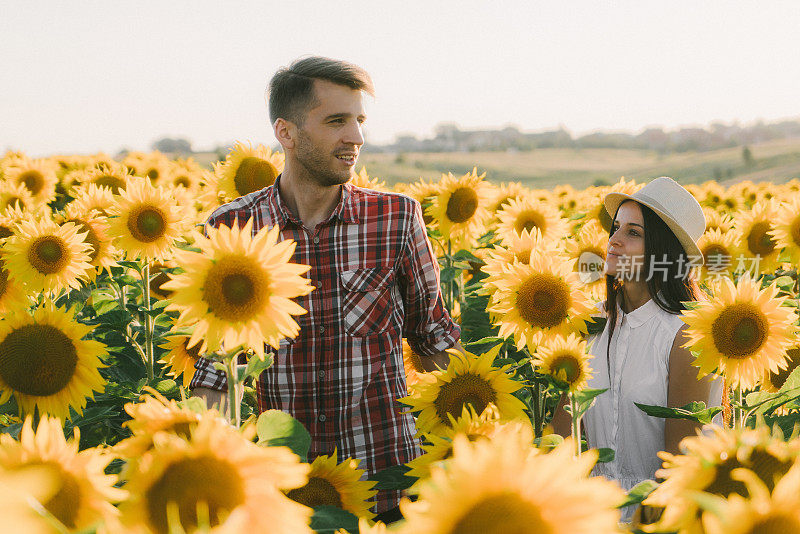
357,139,800,189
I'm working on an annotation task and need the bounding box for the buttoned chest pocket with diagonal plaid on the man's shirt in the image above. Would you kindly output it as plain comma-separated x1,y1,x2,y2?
339,267,394,336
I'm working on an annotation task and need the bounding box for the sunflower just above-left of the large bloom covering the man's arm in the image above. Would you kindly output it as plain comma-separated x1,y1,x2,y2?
110,177,185,260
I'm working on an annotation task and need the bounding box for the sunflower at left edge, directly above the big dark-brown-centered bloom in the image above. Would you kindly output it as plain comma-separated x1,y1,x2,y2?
3,219,92,293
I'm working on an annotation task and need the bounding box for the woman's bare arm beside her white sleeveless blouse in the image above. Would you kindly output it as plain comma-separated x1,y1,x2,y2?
664,325,711,454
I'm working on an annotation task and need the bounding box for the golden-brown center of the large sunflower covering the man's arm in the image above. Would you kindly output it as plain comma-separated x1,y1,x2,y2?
204,256,269,321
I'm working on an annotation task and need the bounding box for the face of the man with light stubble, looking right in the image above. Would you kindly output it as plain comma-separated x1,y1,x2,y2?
294,80,366,186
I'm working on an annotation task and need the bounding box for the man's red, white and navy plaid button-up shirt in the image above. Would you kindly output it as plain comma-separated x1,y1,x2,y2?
191,177,460,513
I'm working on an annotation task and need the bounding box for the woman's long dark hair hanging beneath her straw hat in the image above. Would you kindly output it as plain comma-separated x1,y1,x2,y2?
605,200,702,353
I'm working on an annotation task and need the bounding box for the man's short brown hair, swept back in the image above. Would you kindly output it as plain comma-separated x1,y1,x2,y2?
267,56,375,125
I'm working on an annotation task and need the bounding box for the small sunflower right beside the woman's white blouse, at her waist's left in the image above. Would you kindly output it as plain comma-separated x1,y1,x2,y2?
531,334,593,392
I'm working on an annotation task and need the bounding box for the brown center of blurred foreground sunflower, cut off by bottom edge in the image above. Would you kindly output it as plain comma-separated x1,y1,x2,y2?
450,492,555,534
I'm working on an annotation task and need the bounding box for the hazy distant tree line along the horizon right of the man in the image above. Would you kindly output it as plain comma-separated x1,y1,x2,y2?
376,120,800,153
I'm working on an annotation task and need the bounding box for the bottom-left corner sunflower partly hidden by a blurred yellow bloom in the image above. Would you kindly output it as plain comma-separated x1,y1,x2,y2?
0,415,125,532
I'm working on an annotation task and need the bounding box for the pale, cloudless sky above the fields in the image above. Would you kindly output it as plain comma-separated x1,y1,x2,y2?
0,0,800,155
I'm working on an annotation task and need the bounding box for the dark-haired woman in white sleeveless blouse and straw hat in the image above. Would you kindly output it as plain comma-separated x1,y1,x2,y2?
554,177,721,520
